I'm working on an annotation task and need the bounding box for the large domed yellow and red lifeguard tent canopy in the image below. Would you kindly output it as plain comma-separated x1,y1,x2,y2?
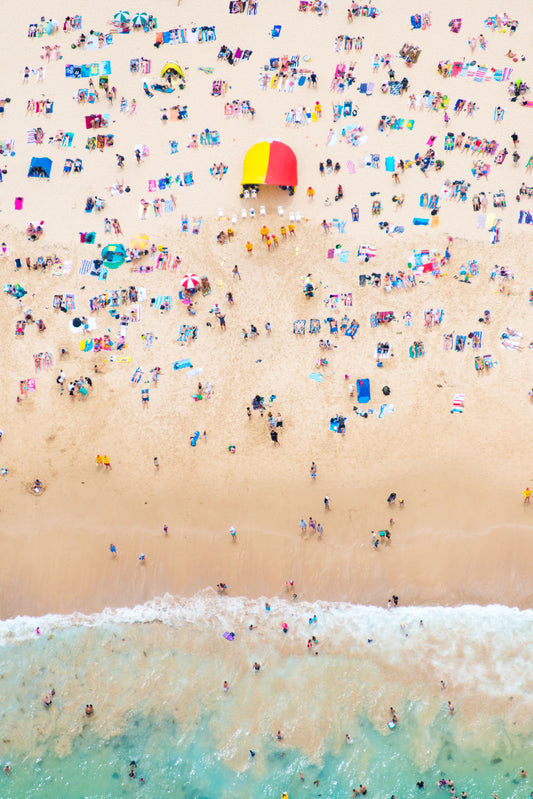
242,141,298,186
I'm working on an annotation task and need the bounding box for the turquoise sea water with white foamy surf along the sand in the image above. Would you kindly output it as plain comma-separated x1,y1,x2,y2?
0,591,533,799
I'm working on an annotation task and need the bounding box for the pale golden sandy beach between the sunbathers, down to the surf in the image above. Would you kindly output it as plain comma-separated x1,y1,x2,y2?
0,0,533,618
